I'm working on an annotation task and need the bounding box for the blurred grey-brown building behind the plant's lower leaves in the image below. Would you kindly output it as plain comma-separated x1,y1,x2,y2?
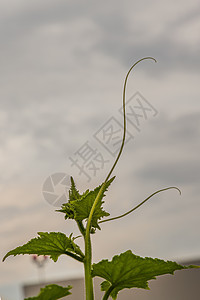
23,260,200,300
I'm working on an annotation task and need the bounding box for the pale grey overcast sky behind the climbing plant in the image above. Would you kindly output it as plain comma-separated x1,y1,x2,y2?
0,0,200,300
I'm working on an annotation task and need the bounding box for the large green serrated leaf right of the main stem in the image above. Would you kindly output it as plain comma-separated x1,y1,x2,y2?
92,250,196,299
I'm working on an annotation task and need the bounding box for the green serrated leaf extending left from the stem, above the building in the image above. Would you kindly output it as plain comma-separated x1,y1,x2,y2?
3,232,83,261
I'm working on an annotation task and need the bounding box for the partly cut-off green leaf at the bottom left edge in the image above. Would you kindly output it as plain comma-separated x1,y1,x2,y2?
24,284,72,300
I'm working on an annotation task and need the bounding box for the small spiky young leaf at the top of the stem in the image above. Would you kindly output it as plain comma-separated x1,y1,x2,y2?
58,177,115,229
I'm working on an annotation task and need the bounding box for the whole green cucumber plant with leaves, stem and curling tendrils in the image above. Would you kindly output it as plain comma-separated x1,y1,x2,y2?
3,57,198,300
